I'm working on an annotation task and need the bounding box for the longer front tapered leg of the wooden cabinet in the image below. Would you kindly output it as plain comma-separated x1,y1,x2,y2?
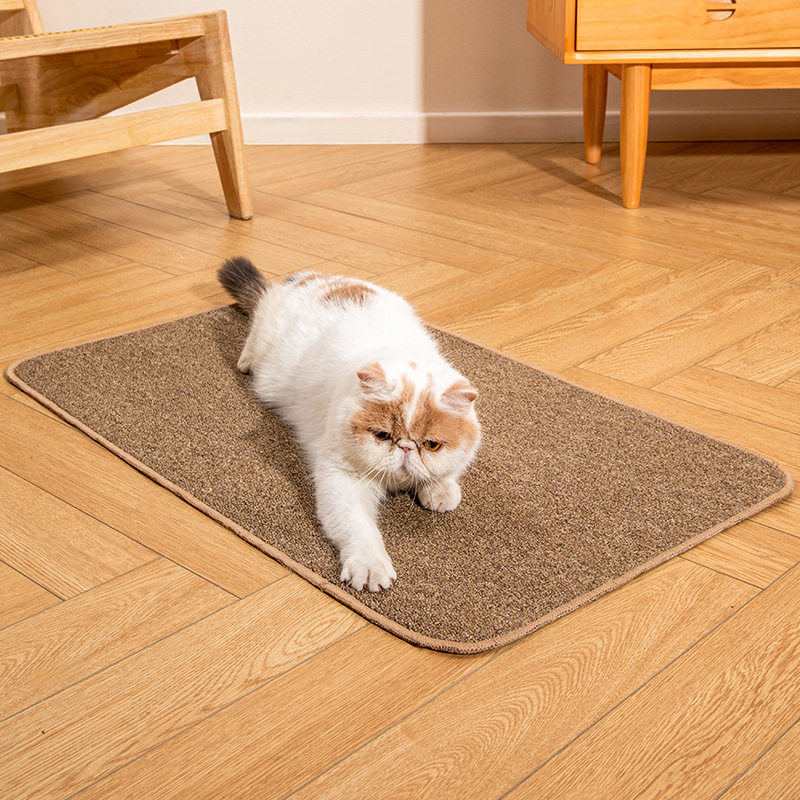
620,64,650,208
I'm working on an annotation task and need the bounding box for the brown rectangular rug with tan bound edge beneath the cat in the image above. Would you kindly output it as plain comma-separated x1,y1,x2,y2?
8,307,792,653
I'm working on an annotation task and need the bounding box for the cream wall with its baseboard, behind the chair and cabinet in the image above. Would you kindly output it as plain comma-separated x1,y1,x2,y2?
39,0,800,143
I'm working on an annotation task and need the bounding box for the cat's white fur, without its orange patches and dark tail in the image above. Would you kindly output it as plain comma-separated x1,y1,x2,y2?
234,276,477,591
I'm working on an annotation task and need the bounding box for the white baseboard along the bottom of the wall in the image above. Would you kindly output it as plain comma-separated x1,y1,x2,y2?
242,108,800,144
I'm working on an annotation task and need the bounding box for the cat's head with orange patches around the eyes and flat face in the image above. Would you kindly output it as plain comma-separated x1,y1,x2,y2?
349,362,480,489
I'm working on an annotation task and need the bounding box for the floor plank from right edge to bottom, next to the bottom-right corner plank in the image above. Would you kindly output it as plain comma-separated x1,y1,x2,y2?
508,567,800,800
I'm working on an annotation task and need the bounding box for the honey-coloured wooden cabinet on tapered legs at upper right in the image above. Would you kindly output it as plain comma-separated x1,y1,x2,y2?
528,0,800,208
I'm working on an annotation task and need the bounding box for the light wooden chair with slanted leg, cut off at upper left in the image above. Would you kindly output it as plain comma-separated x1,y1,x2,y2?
0,0,253,219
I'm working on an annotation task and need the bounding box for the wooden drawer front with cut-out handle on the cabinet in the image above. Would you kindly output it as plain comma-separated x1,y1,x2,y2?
575,0,800,50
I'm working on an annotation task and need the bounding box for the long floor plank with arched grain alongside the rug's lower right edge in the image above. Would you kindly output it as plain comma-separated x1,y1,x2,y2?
286,560,754,800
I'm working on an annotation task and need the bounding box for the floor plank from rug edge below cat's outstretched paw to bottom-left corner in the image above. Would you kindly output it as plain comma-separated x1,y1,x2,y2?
0,576,366,800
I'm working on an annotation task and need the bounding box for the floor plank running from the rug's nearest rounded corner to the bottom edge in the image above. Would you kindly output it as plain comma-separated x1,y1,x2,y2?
73,627,494,800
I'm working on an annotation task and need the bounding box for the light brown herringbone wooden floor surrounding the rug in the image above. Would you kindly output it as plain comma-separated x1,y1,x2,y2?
0,142,800,800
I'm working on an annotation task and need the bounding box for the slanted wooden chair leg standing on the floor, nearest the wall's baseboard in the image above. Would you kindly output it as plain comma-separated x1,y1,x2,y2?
196,11,253,219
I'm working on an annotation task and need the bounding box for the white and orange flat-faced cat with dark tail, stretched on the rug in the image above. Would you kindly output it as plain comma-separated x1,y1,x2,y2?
218,256,481,592
